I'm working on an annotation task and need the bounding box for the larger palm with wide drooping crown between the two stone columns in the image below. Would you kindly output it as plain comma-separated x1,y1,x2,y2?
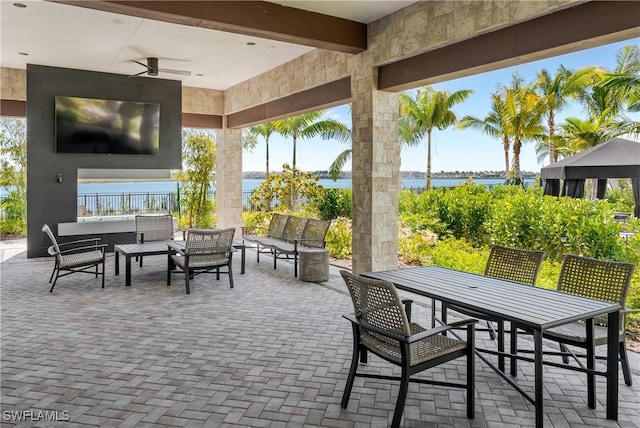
274,110,351,170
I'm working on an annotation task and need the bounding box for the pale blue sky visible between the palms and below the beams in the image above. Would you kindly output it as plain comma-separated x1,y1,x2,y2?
243,39,640,172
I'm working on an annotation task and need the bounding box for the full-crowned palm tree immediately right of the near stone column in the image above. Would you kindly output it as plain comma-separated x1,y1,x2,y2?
398,86,473,190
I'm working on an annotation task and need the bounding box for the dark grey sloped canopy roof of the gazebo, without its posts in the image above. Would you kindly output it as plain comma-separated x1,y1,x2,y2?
540,138,640,180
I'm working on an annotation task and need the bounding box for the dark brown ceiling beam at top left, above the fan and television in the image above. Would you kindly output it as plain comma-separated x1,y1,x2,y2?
49,0,367,54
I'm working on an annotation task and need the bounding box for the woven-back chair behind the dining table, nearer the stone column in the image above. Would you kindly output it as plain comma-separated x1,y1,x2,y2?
442,245,544,372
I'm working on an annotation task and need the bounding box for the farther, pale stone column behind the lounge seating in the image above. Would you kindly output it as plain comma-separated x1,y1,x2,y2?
216,123,242,239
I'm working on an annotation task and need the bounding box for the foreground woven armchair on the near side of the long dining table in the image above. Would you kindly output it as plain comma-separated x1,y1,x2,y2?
340,271,477,427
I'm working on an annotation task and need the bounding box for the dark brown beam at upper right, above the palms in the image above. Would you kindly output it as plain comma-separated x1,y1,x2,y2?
378,1,640,91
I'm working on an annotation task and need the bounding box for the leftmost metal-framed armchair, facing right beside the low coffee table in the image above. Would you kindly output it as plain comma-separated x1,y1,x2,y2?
42,224,107,293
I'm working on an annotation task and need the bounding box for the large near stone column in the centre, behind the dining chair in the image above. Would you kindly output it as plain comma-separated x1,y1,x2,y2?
350,52,400,273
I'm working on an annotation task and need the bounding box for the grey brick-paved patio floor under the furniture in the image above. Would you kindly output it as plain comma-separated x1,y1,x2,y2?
0,243,640,427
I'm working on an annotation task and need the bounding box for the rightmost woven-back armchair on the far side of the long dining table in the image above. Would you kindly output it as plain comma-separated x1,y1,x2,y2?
543,254,634,388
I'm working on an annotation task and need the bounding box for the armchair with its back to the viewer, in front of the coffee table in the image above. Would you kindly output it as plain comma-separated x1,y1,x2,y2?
167,228,235,294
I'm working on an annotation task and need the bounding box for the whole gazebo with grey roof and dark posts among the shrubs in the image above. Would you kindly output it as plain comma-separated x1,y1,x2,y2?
540,138,640,217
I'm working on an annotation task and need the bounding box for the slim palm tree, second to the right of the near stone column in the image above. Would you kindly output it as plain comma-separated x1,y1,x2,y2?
457,93,512,180
